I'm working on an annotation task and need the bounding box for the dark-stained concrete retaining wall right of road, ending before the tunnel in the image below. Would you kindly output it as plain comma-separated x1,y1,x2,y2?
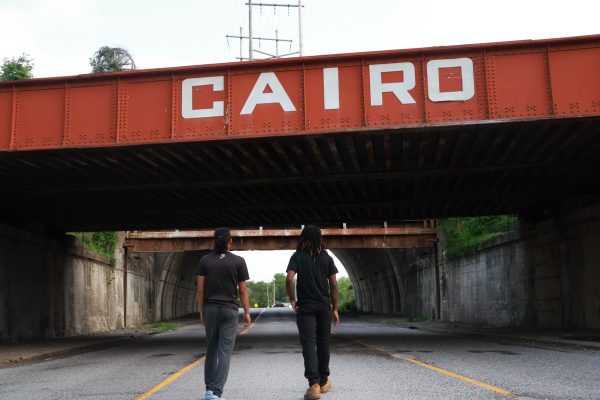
440,205,600,330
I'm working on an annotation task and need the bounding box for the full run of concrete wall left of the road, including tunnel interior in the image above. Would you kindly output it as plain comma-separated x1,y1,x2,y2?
0,224,196,342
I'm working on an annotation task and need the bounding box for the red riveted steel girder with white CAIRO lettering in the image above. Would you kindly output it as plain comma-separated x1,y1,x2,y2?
0,35,600,152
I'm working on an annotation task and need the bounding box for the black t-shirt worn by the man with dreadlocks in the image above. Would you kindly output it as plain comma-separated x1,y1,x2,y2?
286,250,338,305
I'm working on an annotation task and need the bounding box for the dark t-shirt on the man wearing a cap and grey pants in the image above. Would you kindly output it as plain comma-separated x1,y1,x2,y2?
196,252,250,310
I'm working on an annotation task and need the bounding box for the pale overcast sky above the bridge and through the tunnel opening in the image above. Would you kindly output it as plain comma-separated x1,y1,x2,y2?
0,0,600,281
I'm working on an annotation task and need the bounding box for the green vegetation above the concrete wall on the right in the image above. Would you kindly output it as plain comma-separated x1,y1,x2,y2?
440,215,517,260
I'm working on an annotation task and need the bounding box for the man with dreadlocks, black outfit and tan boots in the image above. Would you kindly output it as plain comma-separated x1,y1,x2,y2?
286,225,340,400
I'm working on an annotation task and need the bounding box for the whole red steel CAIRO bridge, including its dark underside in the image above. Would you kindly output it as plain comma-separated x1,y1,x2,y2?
0,35,600,231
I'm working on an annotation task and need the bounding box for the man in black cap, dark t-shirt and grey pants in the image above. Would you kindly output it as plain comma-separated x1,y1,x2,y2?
196,228,251,400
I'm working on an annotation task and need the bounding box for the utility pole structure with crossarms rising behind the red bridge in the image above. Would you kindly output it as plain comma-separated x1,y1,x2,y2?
225,0,304,61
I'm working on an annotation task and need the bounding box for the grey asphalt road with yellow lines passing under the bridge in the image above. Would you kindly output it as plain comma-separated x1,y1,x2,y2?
0,309,600,400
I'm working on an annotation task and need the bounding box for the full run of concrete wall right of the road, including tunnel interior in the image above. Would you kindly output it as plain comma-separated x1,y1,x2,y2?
333,204,600,330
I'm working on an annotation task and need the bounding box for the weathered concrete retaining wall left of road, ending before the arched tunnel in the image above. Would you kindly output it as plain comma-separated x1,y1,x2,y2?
0,225,126,342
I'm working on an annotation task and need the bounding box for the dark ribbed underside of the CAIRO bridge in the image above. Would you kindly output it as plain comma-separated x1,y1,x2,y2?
0,118,600,231
